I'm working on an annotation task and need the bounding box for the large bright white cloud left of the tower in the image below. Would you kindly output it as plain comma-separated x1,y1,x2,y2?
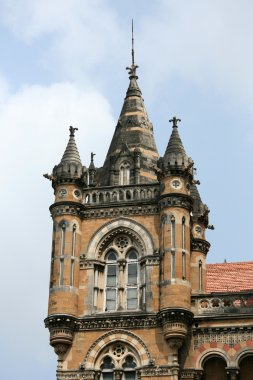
0,79,115,380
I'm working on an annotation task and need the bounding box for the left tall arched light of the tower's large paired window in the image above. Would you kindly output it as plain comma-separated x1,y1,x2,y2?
105,251,118,311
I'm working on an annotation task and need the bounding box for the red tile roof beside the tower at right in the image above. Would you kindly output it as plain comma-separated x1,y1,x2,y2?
206,261,253,293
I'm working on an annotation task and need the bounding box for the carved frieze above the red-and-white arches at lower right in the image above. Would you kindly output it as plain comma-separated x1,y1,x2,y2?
193,326,253,349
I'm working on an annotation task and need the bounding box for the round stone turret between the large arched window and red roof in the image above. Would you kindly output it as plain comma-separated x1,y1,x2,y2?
158,117,193,365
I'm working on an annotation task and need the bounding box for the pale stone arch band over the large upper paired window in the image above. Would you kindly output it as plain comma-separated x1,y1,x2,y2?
87,218,154,257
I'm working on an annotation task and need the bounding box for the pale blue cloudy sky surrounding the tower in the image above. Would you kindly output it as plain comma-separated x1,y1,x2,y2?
0,0,253,380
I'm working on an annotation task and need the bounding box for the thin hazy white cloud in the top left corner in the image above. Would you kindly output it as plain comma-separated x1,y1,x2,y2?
0,0,124,84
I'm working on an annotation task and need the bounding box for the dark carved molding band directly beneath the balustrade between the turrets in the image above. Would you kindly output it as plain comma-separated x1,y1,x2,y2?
81,204,159,219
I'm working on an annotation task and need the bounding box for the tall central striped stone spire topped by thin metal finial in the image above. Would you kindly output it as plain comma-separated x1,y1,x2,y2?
99,20,158,185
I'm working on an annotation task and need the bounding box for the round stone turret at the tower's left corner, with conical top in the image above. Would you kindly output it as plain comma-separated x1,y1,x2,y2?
44,127,86,358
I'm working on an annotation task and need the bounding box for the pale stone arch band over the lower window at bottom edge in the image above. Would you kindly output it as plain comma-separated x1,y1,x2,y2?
82,329,152,369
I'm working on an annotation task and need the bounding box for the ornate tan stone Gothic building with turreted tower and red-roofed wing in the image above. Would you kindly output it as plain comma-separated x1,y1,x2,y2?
45,50,253,380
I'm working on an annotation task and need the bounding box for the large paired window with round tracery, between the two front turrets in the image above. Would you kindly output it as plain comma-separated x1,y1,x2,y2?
93,234,146,312
